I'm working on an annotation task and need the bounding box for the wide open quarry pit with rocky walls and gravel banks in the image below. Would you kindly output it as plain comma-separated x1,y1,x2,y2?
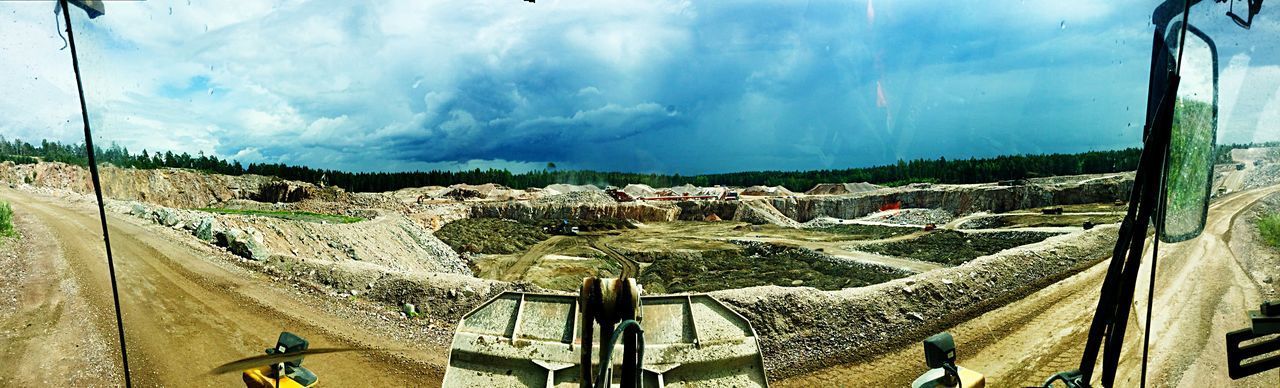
0,163,1152,378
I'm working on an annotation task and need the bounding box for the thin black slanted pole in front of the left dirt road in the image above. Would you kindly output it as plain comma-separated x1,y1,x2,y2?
58,0,133,387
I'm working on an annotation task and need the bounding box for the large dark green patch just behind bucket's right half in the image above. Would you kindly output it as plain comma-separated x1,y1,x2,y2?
639,242,911,293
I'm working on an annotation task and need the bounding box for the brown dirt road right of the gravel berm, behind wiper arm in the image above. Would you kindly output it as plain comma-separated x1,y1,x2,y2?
774,186,1280,387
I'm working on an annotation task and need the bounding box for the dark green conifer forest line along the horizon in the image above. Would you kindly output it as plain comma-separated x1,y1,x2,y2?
0,137,1269,192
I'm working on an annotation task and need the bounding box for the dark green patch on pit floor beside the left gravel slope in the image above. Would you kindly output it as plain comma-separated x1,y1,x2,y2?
435,218,549,254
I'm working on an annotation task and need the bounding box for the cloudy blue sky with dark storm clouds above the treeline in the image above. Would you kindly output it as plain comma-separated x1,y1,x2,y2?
0,0,1280,174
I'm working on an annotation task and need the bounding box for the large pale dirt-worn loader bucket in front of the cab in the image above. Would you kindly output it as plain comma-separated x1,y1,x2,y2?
444,292,768,388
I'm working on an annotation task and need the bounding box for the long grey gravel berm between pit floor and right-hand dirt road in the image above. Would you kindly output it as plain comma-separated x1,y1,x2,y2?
713,227,1116,379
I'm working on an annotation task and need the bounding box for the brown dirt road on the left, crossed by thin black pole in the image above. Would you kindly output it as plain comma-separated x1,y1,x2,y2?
0,190,445,387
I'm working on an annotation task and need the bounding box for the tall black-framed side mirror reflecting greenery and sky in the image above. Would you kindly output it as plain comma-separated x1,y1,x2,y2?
1160,22,1217,242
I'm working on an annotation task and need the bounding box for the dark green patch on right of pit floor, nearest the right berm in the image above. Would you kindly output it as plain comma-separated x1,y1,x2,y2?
859,230,1057,265
